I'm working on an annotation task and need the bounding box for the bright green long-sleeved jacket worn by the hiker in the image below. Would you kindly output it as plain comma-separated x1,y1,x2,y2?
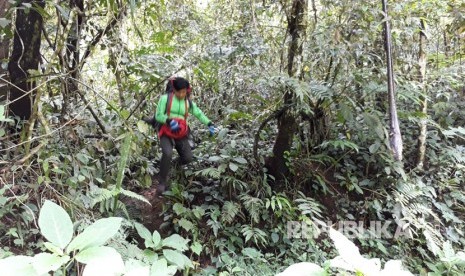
155,94,211,125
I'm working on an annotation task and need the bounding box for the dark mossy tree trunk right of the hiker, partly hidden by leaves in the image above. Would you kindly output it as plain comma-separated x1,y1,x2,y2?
266,0,307,183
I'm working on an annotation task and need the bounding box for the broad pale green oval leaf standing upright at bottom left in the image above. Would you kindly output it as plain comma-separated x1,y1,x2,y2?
39,200,73,249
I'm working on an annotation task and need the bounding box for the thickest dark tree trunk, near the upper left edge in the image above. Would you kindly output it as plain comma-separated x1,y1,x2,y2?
8,0,45,120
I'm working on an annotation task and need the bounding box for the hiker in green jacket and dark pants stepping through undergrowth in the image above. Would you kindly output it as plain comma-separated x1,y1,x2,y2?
144,77,215,194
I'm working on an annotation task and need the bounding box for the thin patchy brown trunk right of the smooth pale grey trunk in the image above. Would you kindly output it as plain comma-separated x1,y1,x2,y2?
417,19,428,170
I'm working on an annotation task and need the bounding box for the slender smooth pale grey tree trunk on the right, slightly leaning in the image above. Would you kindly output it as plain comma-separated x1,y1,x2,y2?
381,0,402,161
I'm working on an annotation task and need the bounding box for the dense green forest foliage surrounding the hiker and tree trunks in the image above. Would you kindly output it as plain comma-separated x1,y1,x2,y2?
0,0,465,275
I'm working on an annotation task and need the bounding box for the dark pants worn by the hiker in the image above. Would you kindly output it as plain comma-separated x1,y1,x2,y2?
159,136,192,186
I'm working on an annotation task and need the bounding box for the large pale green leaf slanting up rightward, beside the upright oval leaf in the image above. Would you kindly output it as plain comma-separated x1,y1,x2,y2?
66,217,123,253
